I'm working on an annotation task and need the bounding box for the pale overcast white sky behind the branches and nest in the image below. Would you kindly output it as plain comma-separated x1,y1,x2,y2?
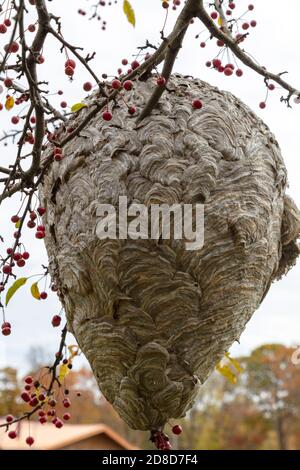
0,0,300,368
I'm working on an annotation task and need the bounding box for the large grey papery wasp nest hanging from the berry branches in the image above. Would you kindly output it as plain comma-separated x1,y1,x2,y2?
41,75,300,430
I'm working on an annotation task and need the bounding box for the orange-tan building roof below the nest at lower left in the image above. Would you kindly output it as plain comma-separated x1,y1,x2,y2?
0,421,137,450
